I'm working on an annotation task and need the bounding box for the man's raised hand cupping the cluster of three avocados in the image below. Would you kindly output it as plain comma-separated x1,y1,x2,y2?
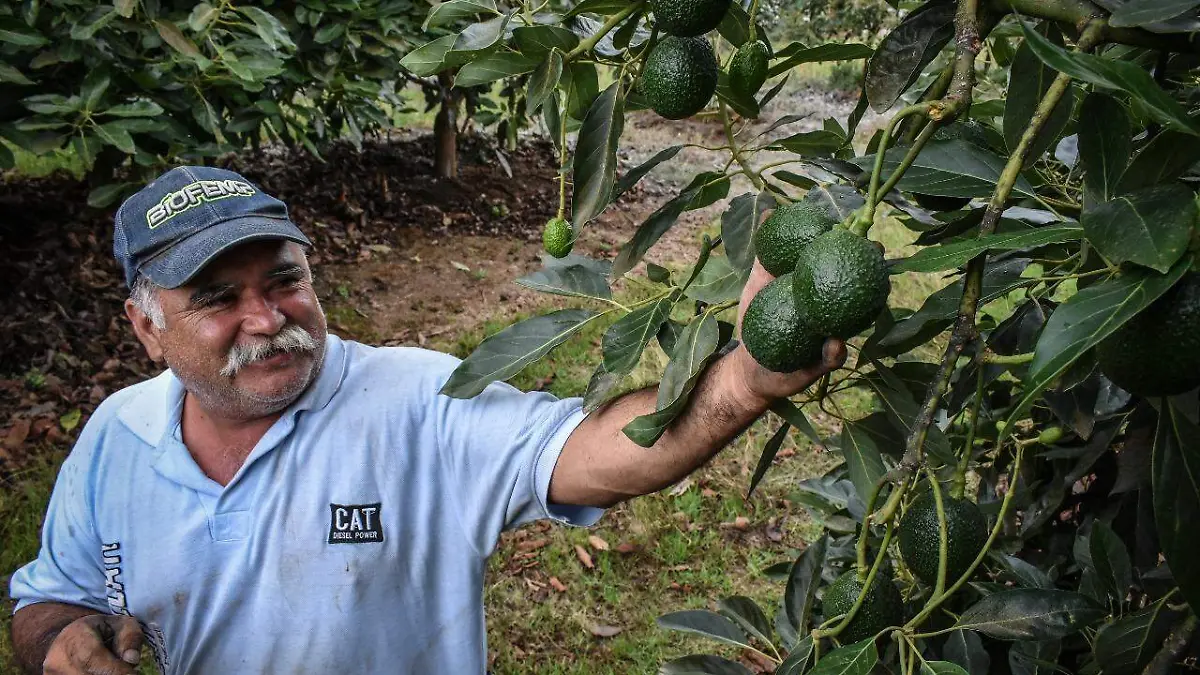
727,253,846,405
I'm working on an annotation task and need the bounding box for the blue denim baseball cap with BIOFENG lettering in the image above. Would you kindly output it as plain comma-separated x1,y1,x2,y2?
113,167,312,288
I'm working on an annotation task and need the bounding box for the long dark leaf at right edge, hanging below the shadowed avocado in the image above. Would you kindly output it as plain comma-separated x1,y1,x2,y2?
1151,401,1200,611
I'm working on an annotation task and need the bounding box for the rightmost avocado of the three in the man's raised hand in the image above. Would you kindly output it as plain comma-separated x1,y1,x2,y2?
792,228,892,339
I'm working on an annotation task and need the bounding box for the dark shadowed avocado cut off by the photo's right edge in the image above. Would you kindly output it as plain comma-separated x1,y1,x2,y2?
1096,271,1200,396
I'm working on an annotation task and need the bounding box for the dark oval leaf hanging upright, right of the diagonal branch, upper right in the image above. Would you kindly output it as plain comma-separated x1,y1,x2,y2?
1079,91,1133,201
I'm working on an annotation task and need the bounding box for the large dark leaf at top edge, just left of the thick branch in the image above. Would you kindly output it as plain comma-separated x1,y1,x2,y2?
863,0,955,113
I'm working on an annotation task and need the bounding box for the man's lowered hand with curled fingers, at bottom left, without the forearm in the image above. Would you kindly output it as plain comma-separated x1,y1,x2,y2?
42,614,144,675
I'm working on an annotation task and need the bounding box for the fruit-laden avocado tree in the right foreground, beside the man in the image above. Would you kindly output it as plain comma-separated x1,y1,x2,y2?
418,0,1200,675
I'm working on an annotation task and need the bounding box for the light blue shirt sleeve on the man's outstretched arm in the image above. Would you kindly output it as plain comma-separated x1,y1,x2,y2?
436,372,604,555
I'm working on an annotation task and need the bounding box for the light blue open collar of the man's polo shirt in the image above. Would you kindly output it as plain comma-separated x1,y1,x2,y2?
118,334,348,447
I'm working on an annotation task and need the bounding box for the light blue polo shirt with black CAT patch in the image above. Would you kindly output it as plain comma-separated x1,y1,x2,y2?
11,335,602,675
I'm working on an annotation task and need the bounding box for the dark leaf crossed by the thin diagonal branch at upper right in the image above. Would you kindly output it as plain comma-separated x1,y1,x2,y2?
1003,23,1075,167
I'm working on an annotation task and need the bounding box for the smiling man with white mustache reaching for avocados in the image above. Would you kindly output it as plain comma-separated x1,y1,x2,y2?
11,167,845,675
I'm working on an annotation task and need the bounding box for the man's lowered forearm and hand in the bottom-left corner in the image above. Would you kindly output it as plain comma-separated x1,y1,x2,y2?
12,603,143,675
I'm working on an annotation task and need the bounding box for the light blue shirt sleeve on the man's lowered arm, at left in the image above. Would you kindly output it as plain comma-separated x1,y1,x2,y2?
8,416,109,614
